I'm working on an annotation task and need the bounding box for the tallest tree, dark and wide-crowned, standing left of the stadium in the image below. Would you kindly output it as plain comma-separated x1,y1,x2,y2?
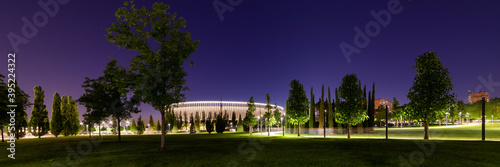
106,1,200,150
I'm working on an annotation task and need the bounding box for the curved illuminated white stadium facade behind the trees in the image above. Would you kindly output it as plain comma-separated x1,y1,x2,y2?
173,101,283,119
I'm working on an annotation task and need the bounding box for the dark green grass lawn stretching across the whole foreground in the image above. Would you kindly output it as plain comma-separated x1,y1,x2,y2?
0,126,500,166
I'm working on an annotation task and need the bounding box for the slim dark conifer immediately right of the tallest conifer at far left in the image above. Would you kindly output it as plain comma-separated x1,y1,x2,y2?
50,92,64,137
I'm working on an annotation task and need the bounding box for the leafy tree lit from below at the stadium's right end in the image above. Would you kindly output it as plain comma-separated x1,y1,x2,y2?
286,80,309,136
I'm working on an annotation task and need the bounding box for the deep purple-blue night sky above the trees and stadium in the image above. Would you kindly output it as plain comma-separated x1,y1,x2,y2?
0,0,500,120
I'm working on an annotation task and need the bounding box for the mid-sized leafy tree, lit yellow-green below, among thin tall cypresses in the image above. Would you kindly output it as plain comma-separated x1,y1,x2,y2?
335,74,368,138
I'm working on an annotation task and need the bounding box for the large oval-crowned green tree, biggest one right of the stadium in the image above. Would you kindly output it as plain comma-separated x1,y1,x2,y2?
407,52,455,139
